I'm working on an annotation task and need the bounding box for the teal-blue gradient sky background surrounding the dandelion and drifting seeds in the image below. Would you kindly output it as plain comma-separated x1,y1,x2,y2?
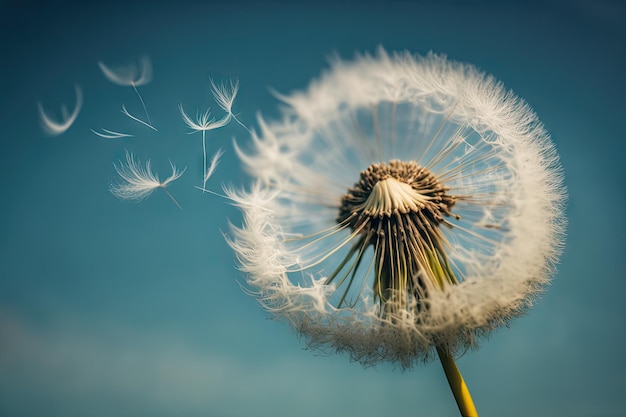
0,1,626,417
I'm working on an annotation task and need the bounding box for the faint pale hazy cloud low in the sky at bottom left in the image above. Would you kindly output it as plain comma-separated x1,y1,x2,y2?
0,315,427,417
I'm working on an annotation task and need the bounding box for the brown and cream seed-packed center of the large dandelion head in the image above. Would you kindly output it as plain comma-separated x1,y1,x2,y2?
329,160,459,310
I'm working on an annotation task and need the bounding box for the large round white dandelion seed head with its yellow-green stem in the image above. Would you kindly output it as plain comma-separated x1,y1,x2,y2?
227,49,565,415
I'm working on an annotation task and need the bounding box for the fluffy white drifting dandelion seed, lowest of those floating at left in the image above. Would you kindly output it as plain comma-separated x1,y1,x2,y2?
110,151,186,210
